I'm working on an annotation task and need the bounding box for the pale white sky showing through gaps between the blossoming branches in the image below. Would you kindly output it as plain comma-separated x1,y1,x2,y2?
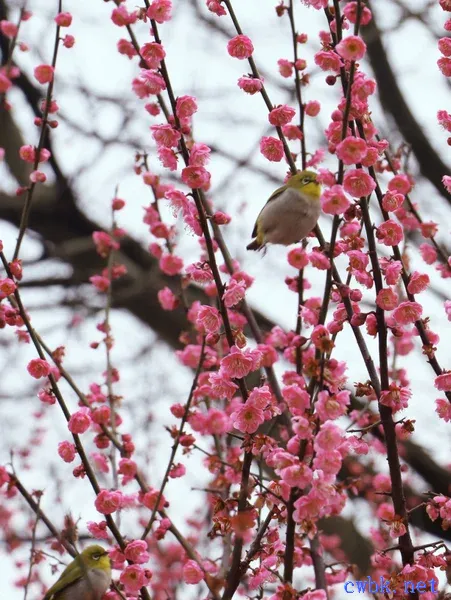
0,0,451,600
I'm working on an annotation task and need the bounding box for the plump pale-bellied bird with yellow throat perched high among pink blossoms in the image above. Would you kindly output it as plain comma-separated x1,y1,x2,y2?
246,170,321,250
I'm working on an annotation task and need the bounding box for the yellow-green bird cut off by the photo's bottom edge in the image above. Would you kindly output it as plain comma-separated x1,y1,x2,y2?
42,544,111,600
